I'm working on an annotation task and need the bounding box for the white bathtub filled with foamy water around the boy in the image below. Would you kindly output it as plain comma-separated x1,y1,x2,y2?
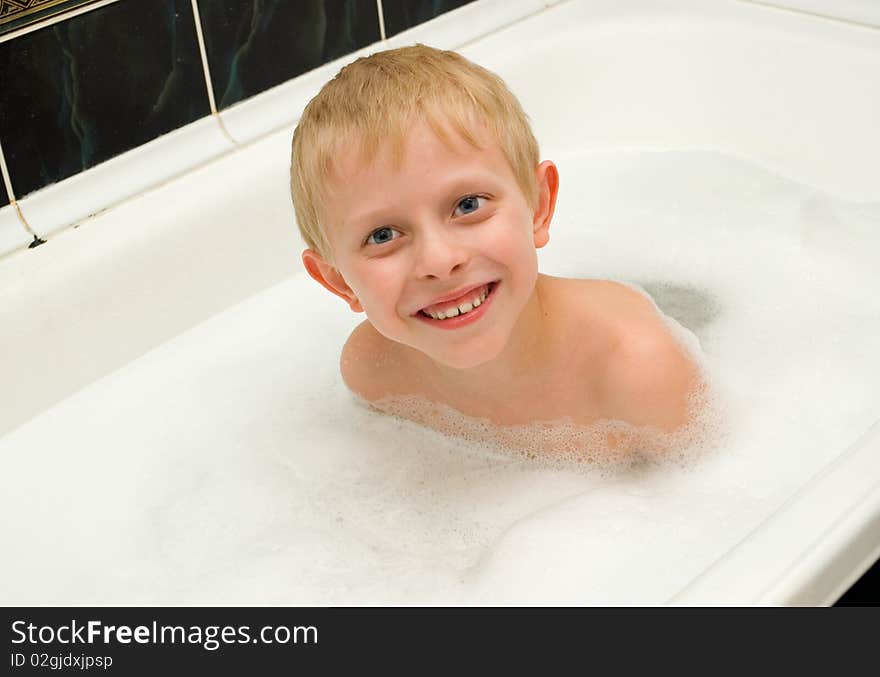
0,0,880,605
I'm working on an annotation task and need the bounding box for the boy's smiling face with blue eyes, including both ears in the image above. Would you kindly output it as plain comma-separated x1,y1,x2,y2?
303,117,557,369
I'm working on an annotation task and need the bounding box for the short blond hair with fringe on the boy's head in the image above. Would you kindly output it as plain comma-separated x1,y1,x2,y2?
290,45,538,261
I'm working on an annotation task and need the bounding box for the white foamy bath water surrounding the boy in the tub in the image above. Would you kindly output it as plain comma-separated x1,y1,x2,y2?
0,152,880,604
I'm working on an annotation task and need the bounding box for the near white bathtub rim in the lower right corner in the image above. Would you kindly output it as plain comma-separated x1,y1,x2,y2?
669,419,880,606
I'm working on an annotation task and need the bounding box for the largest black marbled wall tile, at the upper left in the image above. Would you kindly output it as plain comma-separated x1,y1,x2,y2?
0,0,210,197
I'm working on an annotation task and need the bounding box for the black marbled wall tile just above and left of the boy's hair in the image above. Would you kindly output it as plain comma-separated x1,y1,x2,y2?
199,0,380,110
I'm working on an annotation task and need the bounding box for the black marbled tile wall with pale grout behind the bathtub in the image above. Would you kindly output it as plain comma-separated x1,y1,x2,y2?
0,0,470,207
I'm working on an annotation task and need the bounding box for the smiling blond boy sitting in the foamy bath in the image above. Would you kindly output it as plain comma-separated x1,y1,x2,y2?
291,45,701,451
